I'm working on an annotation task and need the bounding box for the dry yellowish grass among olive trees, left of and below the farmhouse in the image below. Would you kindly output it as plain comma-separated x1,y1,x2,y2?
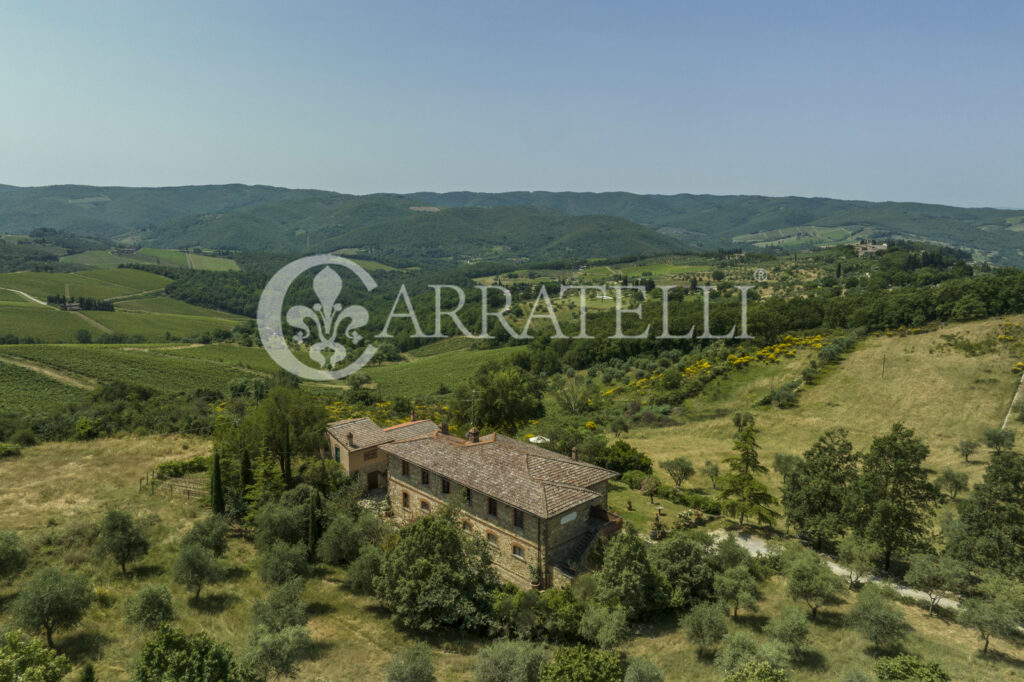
0,437,473,681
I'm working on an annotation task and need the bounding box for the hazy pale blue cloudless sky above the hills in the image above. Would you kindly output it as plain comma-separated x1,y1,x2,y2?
0,0,1024,208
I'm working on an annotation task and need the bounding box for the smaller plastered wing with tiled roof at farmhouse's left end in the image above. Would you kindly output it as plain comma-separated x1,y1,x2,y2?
325,417,437,489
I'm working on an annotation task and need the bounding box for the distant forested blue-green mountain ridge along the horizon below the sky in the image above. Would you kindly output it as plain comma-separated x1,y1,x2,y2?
0,184,1024,265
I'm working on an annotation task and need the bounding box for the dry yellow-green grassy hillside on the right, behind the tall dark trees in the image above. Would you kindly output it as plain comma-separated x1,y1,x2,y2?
626,316,1024,491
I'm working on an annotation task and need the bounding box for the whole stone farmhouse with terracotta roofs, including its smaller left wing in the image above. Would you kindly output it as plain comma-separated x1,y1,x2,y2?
326,419,623,588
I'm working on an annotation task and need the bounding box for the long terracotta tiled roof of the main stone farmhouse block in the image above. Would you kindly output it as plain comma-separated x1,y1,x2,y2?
381,434,617,518
